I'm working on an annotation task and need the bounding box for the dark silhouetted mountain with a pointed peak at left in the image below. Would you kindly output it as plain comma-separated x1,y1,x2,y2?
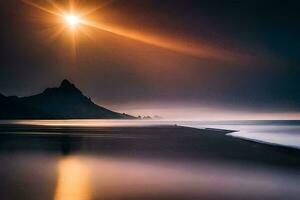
0,80,134,119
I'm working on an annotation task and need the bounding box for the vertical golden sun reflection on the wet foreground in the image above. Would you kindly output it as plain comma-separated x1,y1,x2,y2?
54,157,92,200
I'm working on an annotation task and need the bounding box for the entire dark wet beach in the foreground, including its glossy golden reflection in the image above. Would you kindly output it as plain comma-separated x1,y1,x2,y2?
0,124,300,200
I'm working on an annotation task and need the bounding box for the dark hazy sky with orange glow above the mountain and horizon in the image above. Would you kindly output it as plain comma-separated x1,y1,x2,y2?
0,0,300,119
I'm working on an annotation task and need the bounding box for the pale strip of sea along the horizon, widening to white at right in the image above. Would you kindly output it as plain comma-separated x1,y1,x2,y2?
0,120,300,148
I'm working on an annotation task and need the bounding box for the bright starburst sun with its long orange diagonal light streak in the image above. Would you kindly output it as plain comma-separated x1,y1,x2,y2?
23,0,253,62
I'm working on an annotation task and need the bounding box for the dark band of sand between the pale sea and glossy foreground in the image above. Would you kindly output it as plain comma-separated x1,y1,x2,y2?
0,125,300,169
